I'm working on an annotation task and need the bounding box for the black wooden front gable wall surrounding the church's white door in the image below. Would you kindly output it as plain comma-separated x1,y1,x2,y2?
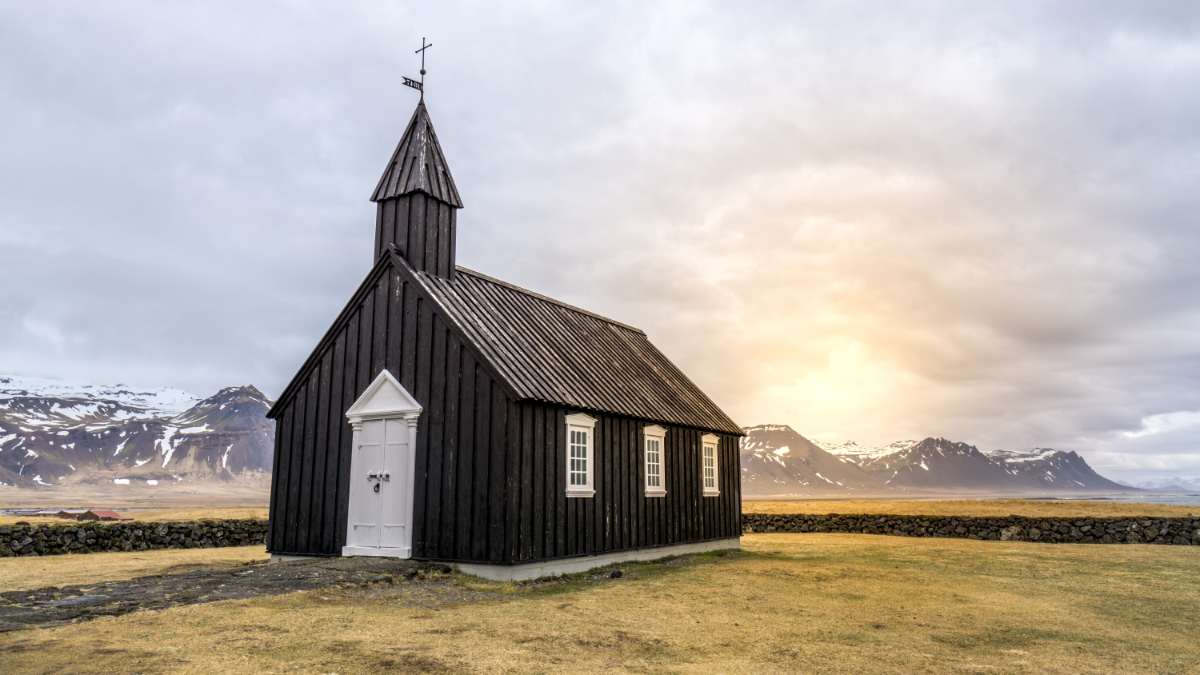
268,263,511,562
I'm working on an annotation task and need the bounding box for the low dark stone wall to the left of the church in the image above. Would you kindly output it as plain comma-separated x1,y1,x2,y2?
0,519,266,557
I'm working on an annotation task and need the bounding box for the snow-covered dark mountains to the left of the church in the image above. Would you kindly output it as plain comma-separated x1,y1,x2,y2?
0,376,274,486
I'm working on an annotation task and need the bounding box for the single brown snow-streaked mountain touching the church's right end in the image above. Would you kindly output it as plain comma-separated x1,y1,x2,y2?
742,424,875,495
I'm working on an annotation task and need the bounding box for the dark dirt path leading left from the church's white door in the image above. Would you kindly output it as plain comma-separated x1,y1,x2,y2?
0,557,439,633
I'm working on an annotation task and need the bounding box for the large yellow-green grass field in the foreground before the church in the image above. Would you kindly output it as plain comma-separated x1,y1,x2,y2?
0,534,1200,673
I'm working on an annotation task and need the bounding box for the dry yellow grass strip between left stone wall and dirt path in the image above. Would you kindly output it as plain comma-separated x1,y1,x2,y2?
0,546,266,592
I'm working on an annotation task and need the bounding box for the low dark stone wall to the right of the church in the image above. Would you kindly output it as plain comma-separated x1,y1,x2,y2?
742,513,1200,545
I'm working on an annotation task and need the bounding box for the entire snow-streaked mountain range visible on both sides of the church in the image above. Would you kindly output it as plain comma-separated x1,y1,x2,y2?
0,376,1129,497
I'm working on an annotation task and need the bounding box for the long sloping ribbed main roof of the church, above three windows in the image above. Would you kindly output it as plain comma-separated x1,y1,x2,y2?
404,263,742,435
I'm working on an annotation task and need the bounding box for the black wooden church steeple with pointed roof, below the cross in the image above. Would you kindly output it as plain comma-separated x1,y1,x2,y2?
371,100,462,279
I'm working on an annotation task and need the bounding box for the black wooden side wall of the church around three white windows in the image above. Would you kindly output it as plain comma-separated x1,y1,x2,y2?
496,402,742,562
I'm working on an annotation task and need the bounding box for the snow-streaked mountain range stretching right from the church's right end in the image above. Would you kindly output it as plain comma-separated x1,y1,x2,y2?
742,424,1130,497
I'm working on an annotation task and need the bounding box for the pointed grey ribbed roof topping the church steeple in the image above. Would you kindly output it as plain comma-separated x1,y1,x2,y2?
371,101,462,209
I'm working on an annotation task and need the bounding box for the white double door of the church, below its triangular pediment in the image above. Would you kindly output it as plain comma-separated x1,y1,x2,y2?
342,418,413,557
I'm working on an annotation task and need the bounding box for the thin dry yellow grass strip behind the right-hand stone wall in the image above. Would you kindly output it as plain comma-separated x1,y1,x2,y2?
742,500,1200,518
